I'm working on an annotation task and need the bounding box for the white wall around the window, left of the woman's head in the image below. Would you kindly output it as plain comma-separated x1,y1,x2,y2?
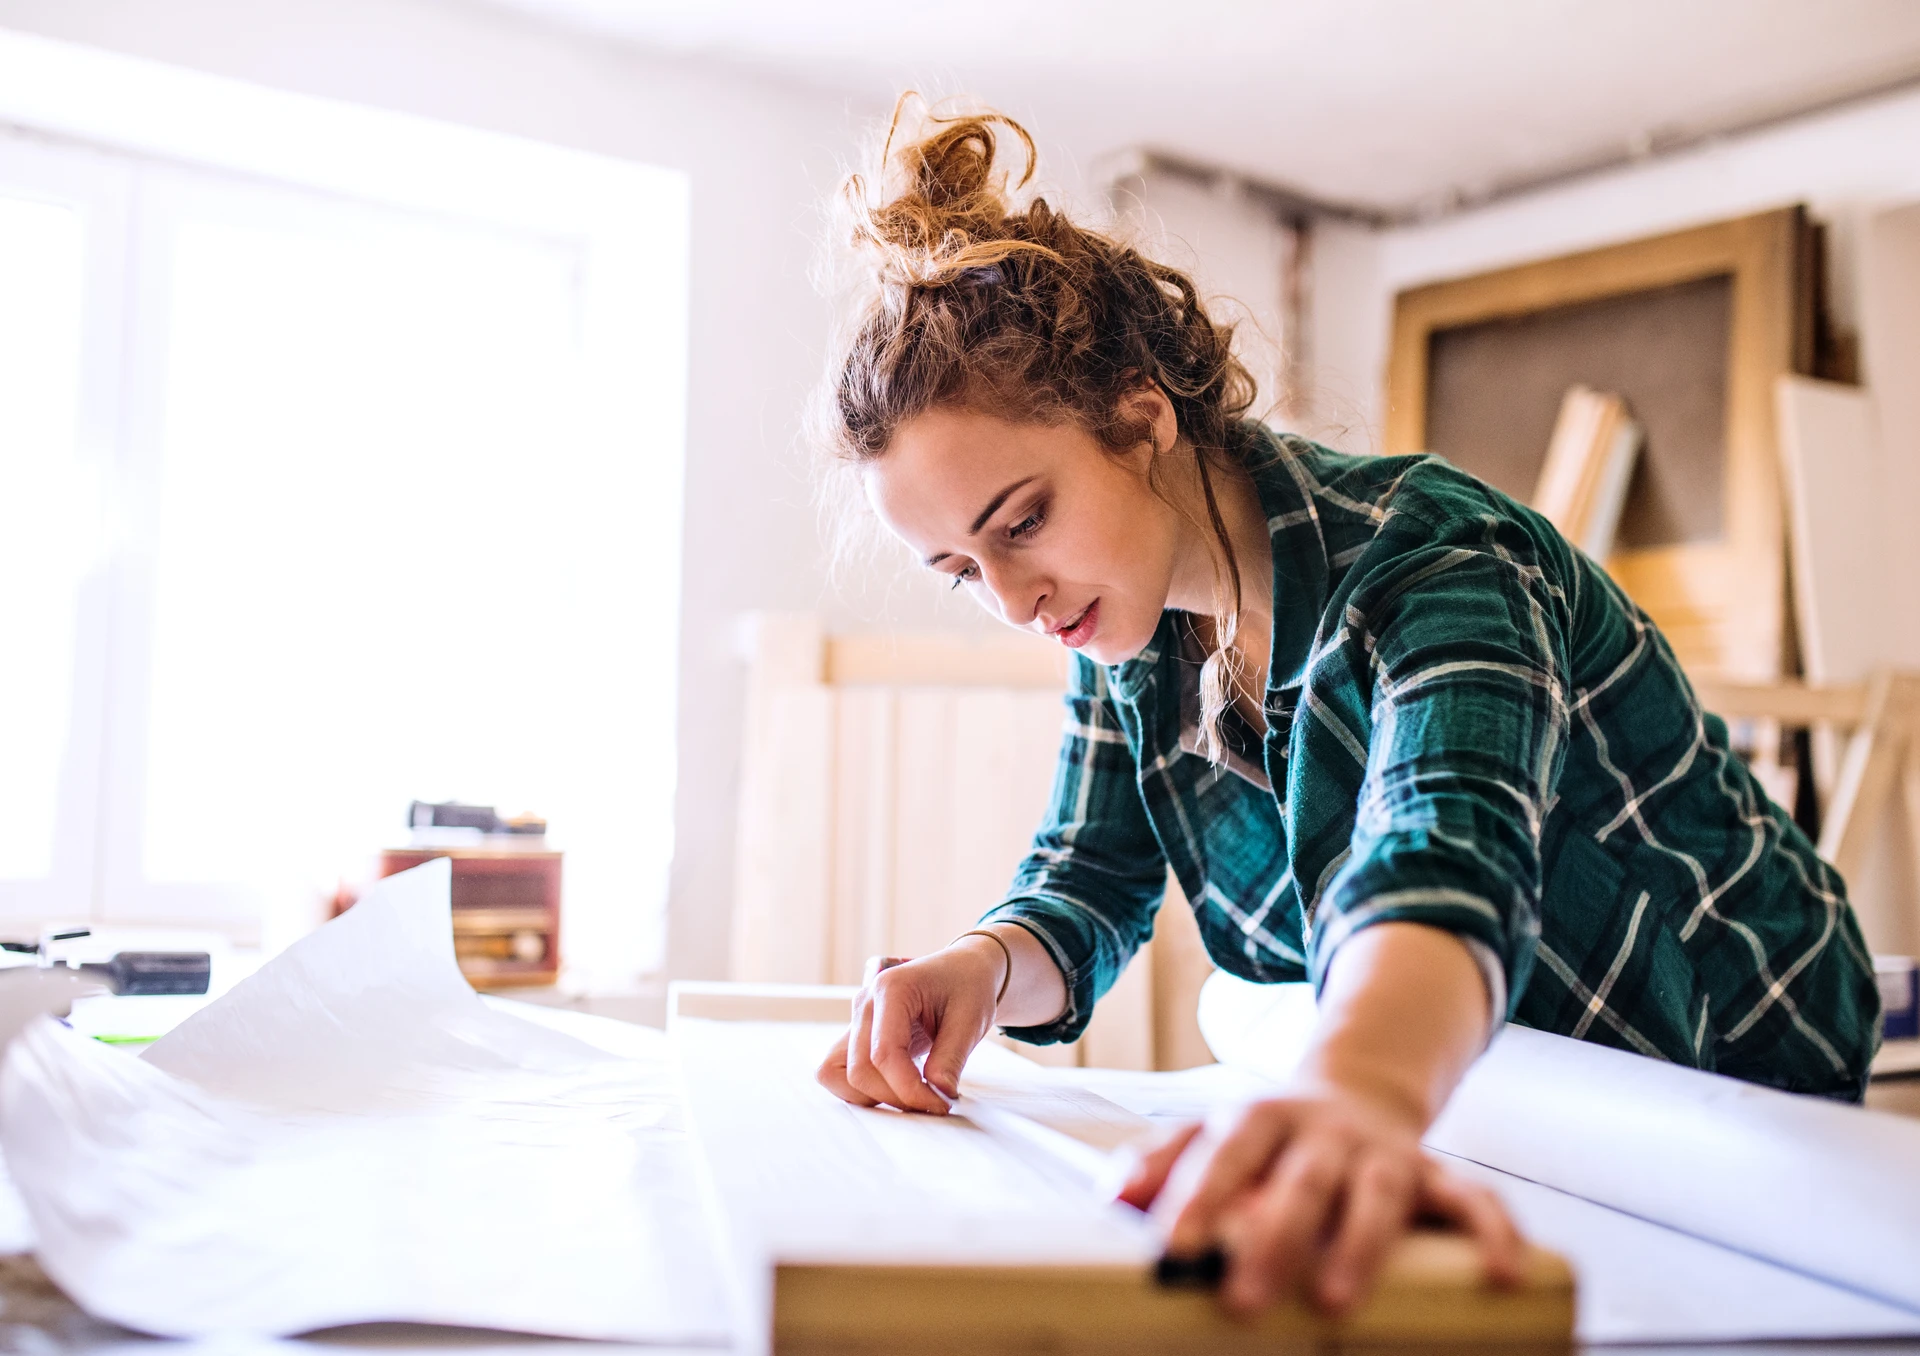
0,0,956,976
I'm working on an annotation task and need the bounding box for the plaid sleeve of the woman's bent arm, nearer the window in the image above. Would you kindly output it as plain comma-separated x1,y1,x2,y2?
981,655,1167,1045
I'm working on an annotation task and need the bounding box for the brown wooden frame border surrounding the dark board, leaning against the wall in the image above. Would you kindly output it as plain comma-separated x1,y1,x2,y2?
1386,207,1812,682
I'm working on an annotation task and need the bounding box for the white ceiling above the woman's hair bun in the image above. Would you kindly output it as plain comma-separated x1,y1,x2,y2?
456,0,1920,213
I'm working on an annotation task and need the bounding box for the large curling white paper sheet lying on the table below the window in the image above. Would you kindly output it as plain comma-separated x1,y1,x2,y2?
0,860,728,1344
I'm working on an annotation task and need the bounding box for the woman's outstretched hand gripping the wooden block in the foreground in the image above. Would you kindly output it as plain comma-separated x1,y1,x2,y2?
1121,1087,1523,1314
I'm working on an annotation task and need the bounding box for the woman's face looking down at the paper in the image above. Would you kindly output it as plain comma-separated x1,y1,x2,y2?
864,392,1185,665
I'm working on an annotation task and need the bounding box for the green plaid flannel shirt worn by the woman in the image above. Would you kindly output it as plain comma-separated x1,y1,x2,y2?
983,424,1880,1099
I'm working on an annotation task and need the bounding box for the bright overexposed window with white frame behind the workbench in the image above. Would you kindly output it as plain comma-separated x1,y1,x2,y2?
0,34,685,987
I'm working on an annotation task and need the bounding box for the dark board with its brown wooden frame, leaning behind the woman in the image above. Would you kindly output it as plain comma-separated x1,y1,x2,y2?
1386,207,1814,682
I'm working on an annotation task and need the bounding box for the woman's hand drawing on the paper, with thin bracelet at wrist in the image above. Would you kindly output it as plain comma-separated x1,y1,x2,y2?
818,933,1008,1116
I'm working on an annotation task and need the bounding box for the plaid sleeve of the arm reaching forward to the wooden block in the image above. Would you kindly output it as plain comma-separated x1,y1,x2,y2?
1306,522,1569,1016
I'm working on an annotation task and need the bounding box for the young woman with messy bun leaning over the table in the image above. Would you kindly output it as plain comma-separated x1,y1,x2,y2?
820,105,1878,1310
